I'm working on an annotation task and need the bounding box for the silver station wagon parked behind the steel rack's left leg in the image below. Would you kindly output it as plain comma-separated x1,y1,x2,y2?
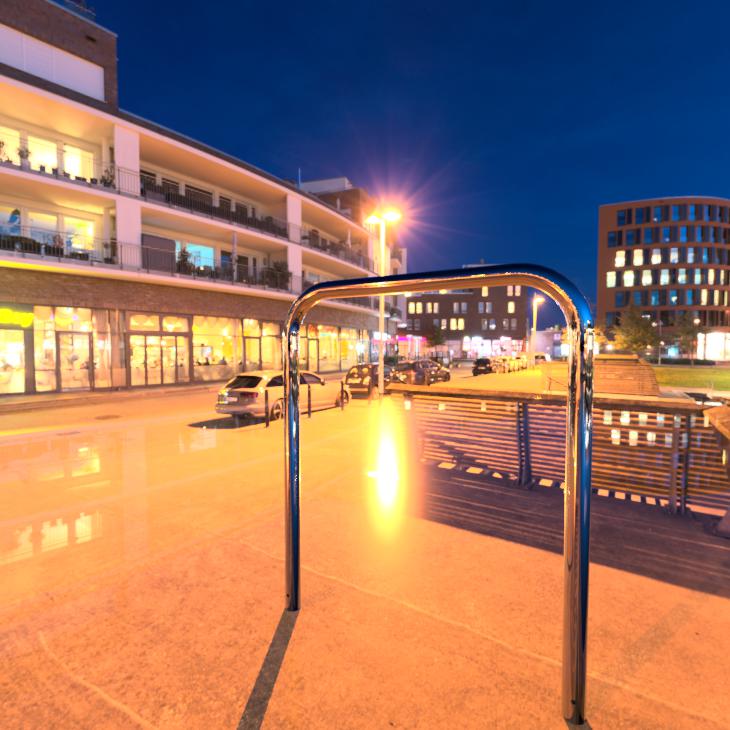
215,370,350,424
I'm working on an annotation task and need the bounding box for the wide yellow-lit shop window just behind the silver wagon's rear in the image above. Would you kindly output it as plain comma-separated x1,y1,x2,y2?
193,317,241,380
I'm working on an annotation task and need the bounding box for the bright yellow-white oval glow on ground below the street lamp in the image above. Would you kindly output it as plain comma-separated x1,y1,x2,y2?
367,398,408,535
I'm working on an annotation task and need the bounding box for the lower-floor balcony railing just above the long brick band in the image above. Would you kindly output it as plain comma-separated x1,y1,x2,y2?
0,226,374,308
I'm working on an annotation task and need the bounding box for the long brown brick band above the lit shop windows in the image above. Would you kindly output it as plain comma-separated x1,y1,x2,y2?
0,268,377,329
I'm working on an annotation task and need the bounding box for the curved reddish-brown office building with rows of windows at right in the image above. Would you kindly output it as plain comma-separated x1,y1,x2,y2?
597,196,730,360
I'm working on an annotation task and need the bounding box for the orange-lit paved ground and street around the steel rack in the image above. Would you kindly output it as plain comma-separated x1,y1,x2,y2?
0,390,730,728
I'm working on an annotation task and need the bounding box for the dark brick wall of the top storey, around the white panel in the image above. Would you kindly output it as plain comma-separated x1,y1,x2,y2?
0,0,119,108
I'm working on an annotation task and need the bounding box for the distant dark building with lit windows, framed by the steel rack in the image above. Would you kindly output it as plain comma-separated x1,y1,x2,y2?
406,286,528,358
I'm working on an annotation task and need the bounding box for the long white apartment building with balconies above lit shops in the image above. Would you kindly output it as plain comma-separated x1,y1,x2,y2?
0,0,402,395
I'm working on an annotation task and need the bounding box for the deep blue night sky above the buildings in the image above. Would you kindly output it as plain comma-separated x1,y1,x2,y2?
91,0,730,324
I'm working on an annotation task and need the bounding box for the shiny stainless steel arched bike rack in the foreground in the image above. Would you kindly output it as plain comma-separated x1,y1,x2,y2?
283,264,594,724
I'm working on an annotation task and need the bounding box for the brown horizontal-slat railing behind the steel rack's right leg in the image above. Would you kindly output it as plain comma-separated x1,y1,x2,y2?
392,385,730,514
